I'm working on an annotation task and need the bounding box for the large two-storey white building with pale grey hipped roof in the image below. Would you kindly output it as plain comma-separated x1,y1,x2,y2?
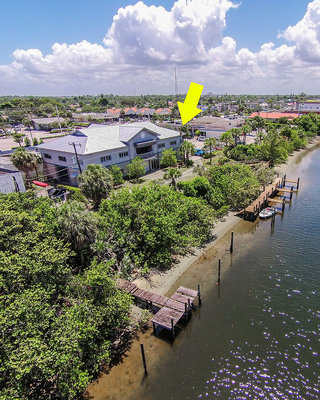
38,121,182,185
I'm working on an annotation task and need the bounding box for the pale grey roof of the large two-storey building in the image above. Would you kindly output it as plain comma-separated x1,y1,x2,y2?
38,121,180,154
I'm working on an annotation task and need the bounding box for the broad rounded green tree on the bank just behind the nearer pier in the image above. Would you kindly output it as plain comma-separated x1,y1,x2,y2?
98,184,213,272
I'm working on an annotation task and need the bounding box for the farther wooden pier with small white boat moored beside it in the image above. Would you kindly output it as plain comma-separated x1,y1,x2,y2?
238,175,300,221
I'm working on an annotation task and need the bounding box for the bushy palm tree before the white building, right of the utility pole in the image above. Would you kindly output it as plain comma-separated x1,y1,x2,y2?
79,164,113,209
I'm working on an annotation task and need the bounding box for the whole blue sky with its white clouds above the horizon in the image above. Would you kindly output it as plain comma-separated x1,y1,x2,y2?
0,0,320,96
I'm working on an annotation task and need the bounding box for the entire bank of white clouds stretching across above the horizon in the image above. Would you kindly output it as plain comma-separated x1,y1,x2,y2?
0,0,320,94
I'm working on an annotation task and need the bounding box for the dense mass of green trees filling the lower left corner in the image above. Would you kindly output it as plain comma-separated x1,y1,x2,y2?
0,192,131,400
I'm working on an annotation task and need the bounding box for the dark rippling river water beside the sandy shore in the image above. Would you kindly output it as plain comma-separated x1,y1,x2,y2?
89,148,320,400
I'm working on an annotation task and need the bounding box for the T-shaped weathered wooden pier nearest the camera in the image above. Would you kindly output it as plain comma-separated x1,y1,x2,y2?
117,279,201,337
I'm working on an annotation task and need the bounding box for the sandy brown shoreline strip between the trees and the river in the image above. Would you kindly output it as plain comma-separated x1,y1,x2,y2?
86,138,320,400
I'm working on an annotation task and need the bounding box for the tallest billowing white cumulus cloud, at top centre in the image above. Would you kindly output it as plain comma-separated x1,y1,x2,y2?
104,0,236,65
